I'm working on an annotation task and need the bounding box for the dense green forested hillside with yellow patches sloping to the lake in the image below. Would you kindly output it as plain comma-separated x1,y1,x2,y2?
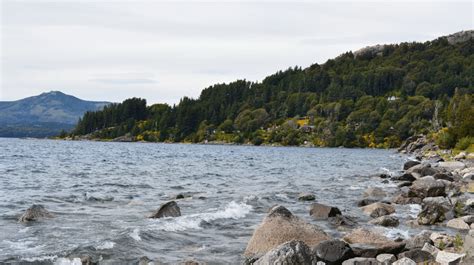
68,31,474,148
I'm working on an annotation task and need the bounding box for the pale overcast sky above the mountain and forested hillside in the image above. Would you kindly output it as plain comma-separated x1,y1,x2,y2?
0,0,474,103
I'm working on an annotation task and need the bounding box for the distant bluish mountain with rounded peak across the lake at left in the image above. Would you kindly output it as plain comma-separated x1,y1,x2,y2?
0,91,109,137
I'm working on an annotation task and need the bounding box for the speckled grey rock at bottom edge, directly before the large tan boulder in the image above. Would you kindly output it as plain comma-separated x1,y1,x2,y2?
254,240,315,265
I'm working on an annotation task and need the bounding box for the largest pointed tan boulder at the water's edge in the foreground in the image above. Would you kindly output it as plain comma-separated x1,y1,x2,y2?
244,205,331,257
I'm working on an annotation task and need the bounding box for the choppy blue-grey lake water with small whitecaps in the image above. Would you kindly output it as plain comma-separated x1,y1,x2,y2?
0,139,409,264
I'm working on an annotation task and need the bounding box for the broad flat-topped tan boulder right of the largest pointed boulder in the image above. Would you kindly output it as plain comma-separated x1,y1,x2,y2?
343,228,405,257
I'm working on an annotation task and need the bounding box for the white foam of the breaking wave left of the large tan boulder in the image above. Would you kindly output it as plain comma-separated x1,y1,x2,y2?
152,201,252,232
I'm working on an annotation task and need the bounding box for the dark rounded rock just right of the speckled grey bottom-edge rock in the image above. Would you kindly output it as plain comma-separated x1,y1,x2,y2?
313,239,354,265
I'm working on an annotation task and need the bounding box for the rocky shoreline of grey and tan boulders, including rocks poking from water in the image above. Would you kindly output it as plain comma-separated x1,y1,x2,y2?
15,136,474,265
